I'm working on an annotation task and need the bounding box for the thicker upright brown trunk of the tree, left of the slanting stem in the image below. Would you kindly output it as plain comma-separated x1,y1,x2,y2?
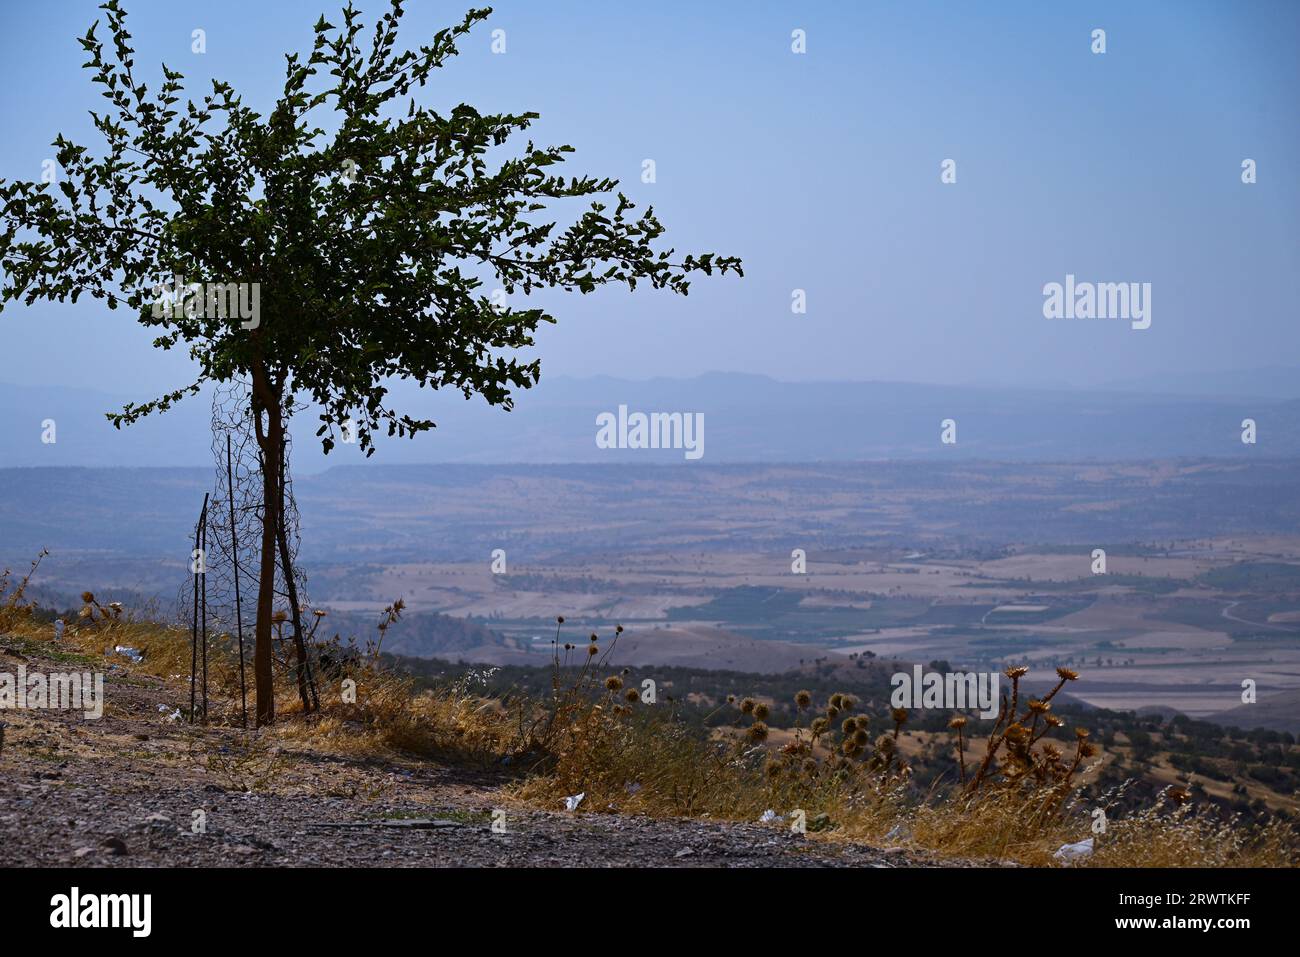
252,363,285,727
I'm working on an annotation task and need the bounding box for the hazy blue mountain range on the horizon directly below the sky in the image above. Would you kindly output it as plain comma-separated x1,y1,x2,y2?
0,369,1300,473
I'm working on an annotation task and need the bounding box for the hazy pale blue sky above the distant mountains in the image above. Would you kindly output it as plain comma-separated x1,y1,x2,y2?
0,0,1300,399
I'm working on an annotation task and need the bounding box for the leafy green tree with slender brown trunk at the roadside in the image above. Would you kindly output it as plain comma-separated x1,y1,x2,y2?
0,0,742,724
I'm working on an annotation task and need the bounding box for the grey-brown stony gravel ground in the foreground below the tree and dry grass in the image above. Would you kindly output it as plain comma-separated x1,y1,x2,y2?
0,636,970,867
